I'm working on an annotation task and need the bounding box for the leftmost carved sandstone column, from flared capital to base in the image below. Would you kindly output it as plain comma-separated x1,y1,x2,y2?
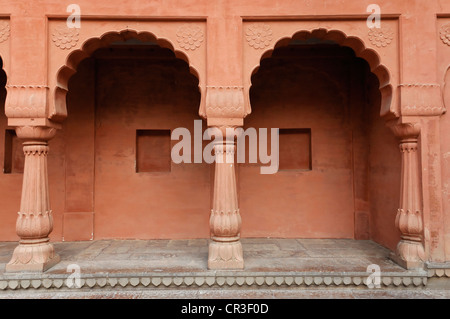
6,126,60,272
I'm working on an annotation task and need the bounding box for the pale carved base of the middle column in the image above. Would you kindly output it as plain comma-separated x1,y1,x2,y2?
208,240,244,269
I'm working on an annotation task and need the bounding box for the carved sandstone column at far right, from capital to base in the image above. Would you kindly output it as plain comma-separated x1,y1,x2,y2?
391,123,425,269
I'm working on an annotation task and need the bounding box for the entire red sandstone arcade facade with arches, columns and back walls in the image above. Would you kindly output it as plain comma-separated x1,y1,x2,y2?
0,0,450,271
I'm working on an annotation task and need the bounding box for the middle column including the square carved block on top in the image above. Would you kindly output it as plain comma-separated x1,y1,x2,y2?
206,86,246,269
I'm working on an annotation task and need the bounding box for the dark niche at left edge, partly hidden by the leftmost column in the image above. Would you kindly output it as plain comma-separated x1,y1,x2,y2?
3,130,25,174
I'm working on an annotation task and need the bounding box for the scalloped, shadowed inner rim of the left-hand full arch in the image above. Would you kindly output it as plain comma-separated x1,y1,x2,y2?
51,29,201,121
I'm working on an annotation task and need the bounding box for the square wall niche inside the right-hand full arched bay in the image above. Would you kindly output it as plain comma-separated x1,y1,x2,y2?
279,128,312,170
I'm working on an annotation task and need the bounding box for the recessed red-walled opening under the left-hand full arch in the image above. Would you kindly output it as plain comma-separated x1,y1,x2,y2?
53,36,210,240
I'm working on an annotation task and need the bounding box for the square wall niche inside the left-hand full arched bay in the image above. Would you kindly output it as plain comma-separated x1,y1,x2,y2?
136,130,172,173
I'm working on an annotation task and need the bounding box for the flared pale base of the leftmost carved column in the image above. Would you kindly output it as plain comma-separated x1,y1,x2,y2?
5,242,61,272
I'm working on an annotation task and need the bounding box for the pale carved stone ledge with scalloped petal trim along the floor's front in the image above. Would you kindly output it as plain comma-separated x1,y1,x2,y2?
0,273,428,291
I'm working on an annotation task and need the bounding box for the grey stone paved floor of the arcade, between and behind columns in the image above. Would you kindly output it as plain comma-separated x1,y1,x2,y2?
0,238,404,274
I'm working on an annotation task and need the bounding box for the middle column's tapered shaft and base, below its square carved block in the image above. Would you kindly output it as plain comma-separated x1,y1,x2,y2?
208,128,244,269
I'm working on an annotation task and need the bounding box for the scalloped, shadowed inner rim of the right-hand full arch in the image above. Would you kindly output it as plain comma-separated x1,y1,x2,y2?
250,28,397,117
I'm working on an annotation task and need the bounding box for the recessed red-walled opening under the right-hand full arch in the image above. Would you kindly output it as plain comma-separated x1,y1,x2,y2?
239,37,401,250
